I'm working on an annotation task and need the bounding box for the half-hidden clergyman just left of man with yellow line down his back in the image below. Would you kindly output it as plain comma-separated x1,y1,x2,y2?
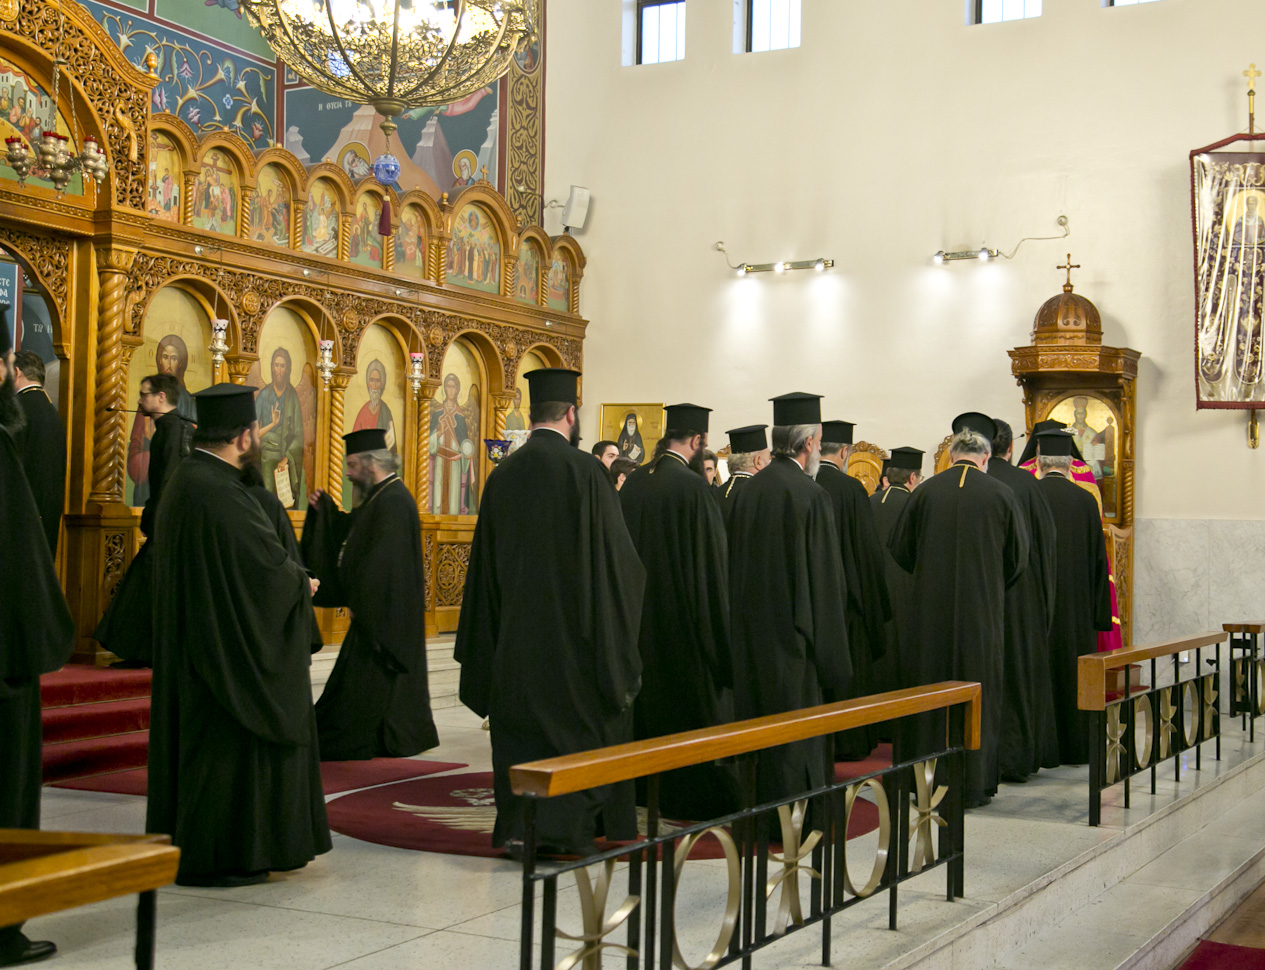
870,448,922,693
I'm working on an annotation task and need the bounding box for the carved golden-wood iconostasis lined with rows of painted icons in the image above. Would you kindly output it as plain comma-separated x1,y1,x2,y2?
0,0,586,660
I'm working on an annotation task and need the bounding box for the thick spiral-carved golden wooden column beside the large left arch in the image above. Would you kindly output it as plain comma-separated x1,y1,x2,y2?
89,247,137,505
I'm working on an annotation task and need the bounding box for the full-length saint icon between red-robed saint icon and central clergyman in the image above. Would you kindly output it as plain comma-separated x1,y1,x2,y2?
428,338,486,515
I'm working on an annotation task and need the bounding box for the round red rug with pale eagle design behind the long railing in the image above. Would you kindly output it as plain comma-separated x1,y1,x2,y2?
326,771,878,859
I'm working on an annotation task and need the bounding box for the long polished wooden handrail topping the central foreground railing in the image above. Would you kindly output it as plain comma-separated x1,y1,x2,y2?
510,680,979,798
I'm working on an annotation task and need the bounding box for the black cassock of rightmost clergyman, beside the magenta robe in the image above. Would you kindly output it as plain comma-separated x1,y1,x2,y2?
1037,473,1112,765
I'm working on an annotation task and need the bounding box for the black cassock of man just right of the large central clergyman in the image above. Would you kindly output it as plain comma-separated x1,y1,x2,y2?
620,451,737,820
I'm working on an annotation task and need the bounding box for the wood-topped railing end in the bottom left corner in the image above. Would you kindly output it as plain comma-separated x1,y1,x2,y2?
0,828,180,970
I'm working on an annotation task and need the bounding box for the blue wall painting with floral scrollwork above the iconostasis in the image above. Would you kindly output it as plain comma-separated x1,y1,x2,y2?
83,0,277,150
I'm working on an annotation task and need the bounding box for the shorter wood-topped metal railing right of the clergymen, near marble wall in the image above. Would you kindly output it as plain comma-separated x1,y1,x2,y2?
1077,632,1228,826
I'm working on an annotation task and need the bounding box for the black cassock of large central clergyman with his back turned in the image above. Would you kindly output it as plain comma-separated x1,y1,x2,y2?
455,429,645,852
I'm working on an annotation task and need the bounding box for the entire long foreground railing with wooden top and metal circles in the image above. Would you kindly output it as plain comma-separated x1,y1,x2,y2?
510,682,980,970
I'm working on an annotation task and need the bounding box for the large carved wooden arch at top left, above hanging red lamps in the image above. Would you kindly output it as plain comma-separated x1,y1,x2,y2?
0,0,158,211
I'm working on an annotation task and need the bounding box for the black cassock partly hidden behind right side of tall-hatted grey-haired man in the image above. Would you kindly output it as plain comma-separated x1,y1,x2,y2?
817,462,892,761
